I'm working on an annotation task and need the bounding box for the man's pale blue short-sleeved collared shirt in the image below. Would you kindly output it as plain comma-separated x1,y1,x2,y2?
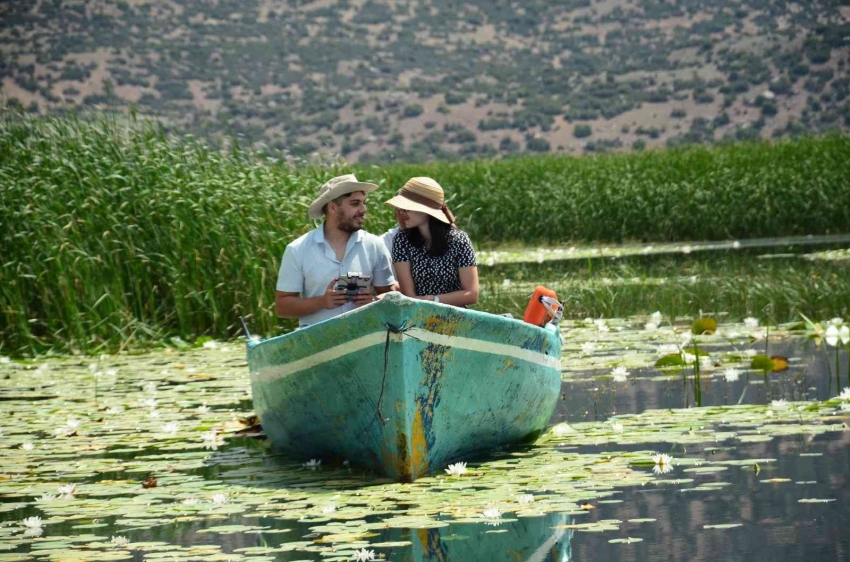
277,223,395,326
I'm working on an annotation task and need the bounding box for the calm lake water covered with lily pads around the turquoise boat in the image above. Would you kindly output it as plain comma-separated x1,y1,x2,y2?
0,326,850,562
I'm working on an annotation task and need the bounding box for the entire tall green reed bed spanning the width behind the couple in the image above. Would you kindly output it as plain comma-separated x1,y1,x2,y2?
0,113,850,355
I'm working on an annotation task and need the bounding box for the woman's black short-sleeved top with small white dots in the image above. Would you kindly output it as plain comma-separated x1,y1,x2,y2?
392,228,477,296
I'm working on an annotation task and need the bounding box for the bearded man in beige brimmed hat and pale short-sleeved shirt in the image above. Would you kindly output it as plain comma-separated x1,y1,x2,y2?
274,174,395,327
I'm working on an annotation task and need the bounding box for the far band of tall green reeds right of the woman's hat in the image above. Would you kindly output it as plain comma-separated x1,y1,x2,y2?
387,136,850,243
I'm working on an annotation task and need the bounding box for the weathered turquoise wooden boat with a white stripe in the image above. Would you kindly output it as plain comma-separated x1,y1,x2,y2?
248,293,561,481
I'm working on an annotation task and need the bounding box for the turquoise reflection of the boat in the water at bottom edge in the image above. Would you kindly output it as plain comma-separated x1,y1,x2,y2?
380,513,573,562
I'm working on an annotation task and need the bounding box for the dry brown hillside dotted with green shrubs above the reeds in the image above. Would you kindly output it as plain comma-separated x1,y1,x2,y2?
0,0,850,161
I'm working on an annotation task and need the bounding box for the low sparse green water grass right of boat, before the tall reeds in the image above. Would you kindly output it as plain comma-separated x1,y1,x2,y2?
479,253,850,323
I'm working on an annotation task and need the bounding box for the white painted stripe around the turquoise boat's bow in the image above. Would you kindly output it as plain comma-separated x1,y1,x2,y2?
258,328,561,380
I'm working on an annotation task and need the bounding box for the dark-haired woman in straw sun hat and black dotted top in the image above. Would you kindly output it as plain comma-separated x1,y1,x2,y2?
387,177,478,306
